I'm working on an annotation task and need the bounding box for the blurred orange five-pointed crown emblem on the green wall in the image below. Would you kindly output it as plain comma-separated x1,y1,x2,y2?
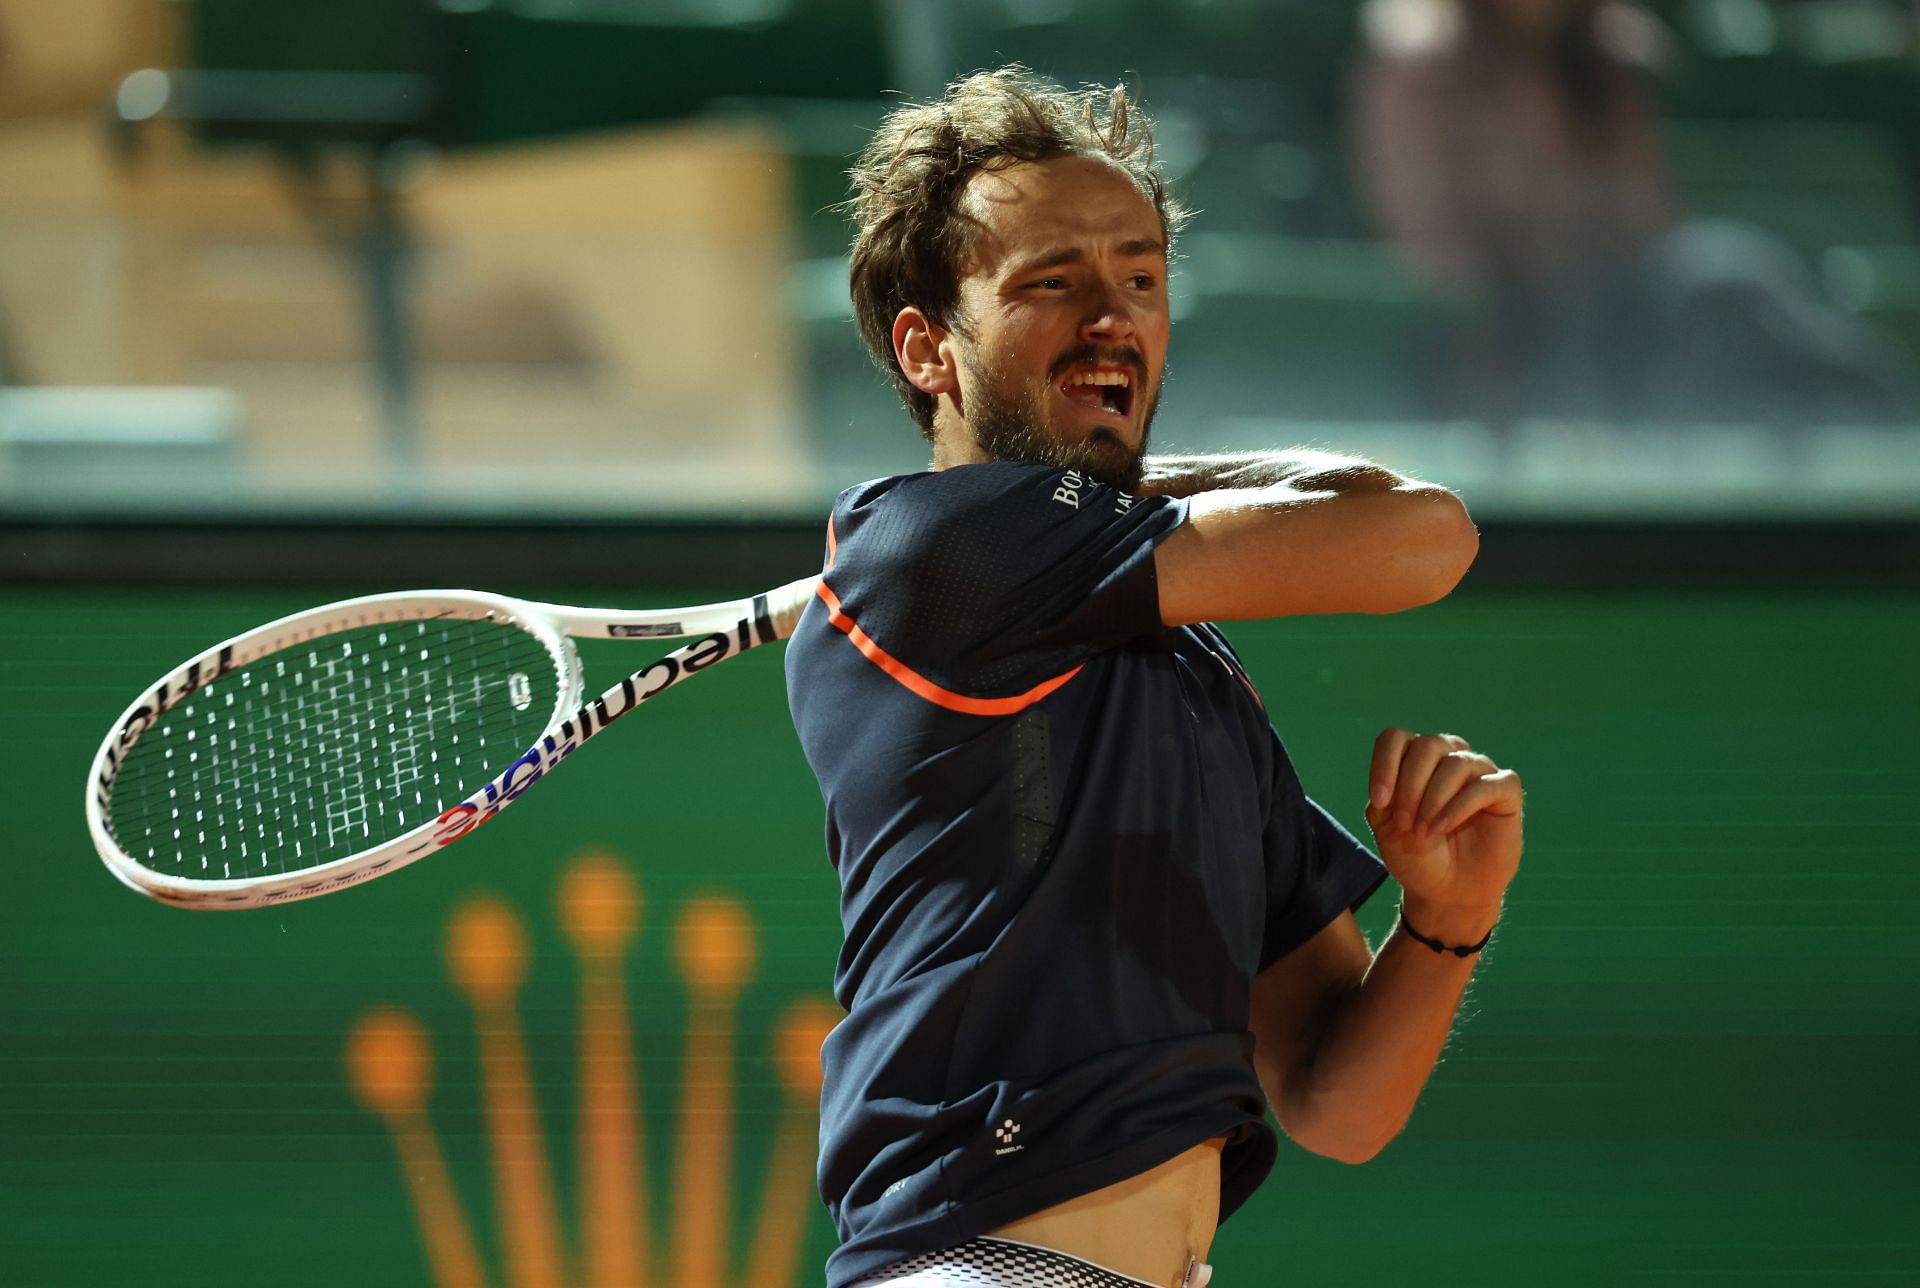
344,852,841,1288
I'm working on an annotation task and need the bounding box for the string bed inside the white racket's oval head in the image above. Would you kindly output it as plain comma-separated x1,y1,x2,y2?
109,618,563,879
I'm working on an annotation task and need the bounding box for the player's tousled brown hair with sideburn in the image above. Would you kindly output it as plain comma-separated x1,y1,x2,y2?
847,63,1188,440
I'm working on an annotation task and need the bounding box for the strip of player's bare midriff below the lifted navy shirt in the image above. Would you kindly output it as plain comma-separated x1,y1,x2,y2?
993,1138,1225,1288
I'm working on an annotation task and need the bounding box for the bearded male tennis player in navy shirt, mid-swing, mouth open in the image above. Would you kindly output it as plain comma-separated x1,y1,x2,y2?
787,69,1521,1288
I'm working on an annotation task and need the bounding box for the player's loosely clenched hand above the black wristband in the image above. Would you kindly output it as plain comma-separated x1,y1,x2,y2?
1367,729,1521,944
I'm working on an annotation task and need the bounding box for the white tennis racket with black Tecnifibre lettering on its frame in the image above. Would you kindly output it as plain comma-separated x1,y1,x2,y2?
86,578,818,908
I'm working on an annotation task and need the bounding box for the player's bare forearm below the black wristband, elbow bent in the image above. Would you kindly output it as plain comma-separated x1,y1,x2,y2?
1290,902,1500,1163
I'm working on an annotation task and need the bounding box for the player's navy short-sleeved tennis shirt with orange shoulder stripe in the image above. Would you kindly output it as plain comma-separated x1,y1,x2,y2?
787,463,1386,1288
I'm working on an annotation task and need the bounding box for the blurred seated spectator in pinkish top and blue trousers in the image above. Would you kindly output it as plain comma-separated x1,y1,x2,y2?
1356,0,1908,433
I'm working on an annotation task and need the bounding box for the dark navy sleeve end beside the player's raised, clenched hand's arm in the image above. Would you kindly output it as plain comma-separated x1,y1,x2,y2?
1260,747,1386,969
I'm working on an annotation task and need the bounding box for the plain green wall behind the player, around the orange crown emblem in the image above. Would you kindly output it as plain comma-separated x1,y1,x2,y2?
0,585,1920,1288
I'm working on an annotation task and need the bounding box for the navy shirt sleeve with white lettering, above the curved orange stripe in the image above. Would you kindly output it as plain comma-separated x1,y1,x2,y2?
826,463,1187,699
